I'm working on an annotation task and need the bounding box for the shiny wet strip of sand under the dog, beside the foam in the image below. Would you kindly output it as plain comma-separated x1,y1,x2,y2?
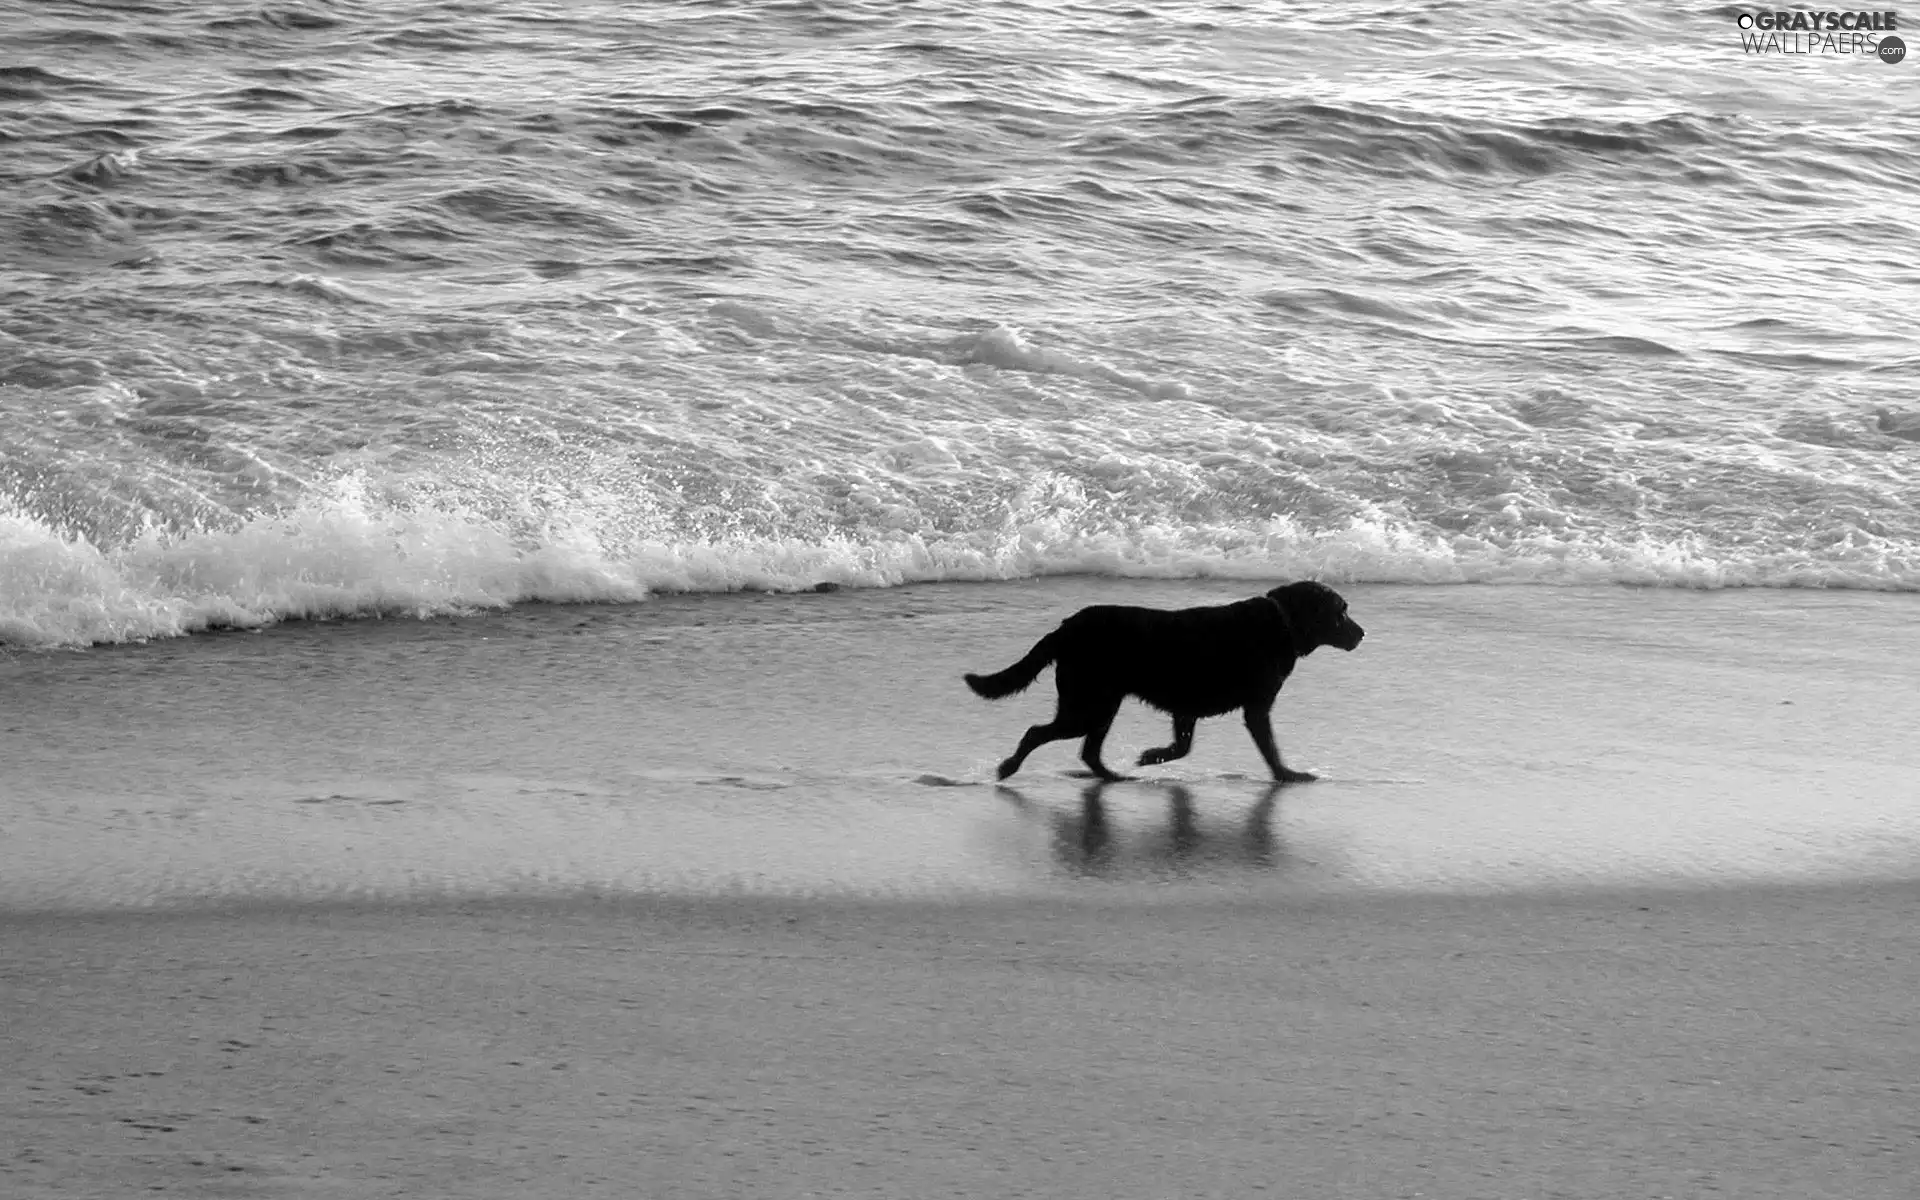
0,580,1920,908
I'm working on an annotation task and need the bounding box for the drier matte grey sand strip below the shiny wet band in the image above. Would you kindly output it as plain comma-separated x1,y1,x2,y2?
0,883,1920,1200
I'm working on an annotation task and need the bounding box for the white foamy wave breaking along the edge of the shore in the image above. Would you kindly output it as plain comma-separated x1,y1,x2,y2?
0,476,1920,649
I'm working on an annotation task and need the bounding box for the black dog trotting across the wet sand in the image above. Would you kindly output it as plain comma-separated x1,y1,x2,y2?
966,582,1367,783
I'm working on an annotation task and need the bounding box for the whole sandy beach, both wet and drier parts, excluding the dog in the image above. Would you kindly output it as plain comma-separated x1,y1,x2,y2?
0,580,1920,1200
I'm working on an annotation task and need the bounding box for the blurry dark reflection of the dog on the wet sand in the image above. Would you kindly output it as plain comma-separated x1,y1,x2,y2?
996,780,1284,876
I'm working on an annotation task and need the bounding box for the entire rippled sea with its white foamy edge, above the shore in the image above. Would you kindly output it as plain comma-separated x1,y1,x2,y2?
0,2,1920,645
